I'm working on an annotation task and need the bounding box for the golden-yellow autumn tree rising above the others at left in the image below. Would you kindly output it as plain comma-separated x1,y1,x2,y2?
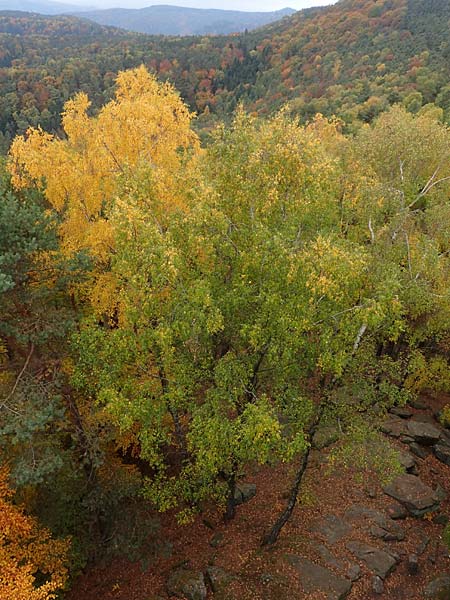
9,66,198,311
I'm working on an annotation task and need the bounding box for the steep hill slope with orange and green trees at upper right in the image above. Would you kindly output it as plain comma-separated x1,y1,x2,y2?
214,0,450,121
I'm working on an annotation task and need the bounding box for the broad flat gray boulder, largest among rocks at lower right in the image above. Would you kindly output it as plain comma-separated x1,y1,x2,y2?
383,473,439,517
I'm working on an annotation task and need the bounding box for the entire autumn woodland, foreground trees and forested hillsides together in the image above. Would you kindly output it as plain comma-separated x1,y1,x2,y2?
0,0,450,600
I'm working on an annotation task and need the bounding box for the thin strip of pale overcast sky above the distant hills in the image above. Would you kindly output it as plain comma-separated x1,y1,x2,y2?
66,0,333,11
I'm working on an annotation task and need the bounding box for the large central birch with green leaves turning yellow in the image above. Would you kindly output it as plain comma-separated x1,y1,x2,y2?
74,112,398,516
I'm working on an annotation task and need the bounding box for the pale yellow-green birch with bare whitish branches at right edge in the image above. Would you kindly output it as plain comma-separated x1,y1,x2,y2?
347,107,450,398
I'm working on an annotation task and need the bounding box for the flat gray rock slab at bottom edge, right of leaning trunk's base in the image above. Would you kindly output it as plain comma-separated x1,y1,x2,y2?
287,554,352,600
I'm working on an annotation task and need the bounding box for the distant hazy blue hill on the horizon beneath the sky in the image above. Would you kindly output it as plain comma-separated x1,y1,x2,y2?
75,5,295,35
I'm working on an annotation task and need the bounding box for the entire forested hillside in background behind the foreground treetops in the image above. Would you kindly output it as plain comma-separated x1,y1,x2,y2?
0,0,450,147
